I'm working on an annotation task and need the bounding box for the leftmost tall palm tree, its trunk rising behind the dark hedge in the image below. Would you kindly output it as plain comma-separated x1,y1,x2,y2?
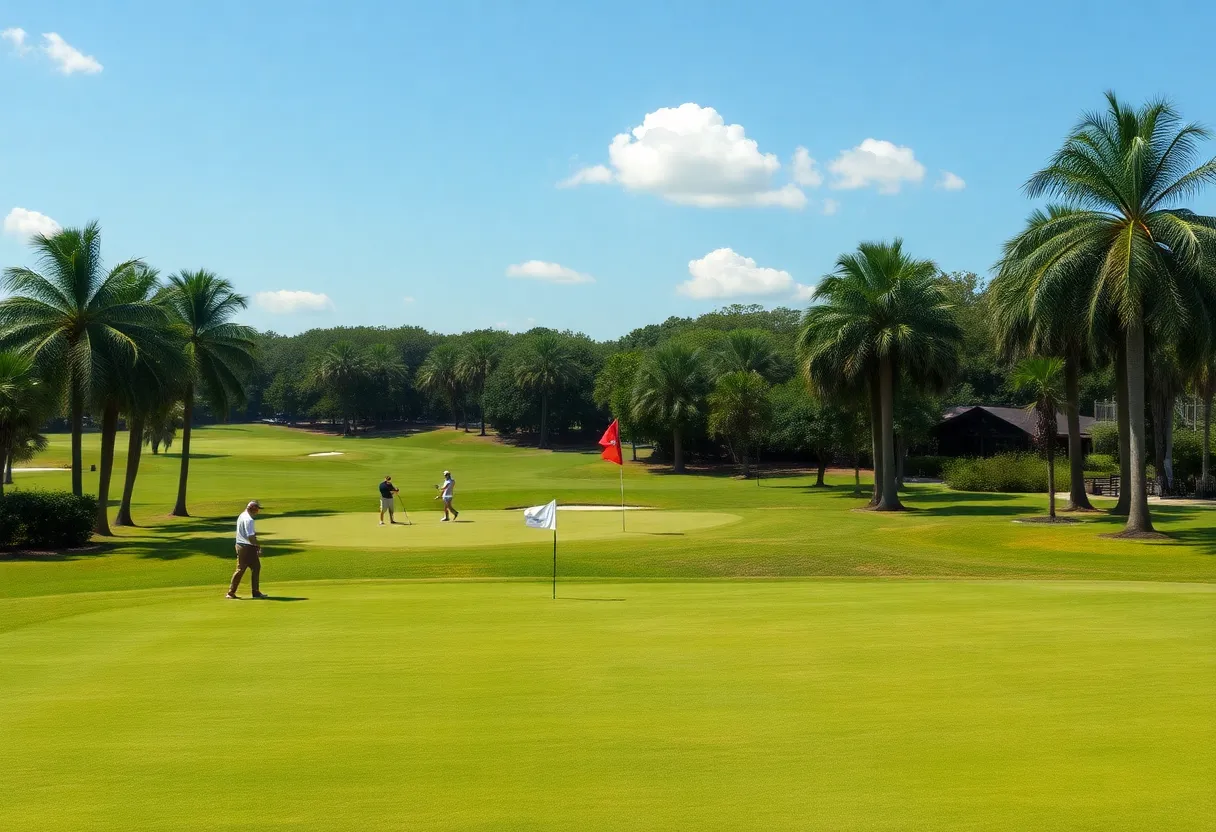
0,223,148,495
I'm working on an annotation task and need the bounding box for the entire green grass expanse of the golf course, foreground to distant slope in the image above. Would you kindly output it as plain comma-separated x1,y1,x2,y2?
0,427,1216,830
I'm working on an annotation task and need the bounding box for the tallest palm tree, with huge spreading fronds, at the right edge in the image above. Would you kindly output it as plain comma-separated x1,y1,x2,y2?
1004,92,1216,536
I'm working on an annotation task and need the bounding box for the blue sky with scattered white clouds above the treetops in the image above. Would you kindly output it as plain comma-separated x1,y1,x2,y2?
0,0,1216,338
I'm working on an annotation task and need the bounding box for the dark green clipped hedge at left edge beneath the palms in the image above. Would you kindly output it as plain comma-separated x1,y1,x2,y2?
0,491,97,549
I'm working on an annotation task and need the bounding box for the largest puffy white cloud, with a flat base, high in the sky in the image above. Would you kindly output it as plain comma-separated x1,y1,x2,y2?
562,103,806,208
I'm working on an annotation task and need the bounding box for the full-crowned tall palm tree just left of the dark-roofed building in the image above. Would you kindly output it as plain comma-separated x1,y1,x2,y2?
800,238,962,511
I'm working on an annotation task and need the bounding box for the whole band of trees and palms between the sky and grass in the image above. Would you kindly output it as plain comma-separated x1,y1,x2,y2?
0,95,1216,535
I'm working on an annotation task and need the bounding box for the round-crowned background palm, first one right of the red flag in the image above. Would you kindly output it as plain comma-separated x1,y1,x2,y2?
631,341,706,473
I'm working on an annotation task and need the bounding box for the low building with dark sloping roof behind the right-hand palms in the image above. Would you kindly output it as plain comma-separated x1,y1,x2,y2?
930,405,1096,456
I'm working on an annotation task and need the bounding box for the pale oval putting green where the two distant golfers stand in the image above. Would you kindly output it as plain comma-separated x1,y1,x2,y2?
258,511,739,550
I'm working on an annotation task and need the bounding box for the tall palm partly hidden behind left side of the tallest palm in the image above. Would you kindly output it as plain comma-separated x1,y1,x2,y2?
990,237,1100,511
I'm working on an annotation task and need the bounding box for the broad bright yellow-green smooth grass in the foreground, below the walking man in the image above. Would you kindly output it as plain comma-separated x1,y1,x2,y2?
0,581,1216,830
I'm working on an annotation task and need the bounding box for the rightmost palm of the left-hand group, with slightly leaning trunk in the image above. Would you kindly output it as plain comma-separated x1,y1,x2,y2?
162,269,255,517
